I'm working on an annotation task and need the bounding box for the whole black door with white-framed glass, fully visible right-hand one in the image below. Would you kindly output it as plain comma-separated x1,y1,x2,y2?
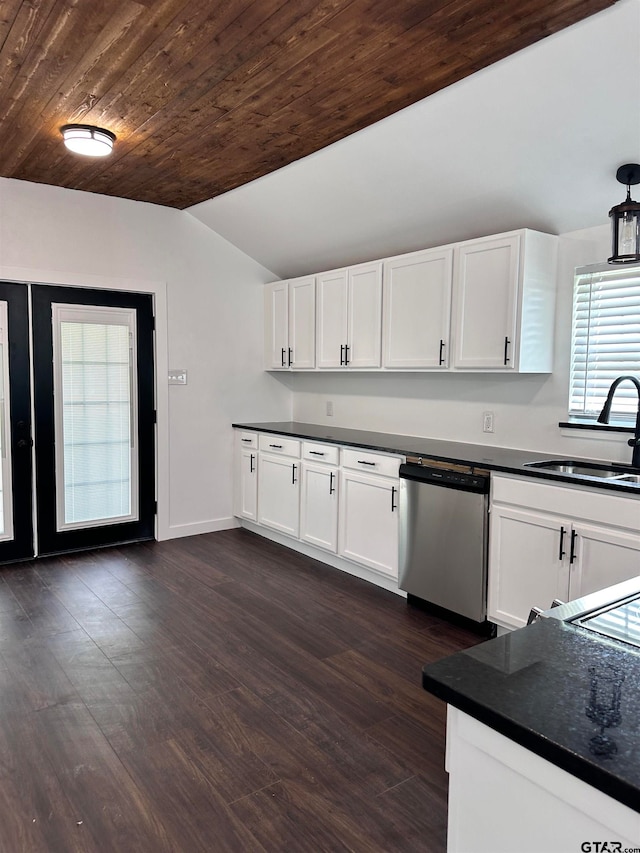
32,285,155,555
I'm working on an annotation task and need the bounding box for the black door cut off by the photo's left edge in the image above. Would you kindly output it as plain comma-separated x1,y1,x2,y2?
0,282,34,563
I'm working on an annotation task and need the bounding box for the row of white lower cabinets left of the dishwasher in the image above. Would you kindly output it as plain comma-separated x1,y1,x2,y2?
234,429,402,588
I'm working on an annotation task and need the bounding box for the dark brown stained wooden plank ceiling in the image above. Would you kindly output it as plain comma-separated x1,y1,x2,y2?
0,0,616,208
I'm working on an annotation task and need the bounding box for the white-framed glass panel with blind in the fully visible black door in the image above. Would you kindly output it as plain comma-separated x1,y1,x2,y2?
52,303,138,531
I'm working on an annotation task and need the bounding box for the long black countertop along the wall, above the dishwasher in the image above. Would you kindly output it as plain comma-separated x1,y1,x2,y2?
233,421,640,494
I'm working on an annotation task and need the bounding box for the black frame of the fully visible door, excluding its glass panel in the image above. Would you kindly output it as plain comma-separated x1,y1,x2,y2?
31,284,156,556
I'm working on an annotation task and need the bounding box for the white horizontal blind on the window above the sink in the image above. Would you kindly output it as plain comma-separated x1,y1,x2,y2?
569,267,640,423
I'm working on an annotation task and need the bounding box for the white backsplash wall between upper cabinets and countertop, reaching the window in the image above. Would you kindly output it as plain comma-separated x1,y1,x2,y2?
292,225,631,462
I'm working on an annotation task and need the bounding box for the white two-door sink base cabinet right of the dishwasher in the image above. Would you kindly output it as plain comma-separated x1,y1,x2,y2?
488,476,640,628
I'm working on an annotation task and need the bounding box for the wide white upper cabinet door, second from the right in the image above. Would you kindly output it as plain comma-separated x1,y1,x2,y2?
382,249,453,369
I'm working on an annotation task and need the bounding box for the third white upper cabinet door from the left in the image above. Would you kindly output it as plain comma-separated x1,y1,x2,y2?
316,270,347,368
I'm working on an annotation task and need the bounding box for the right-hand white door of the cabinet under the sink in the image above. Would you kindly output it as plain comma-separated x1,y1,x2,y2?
569,520,640,600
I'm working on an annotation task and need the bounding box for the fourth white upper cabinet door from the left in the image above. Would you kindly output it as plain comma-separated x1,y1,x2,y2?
347,263,382,367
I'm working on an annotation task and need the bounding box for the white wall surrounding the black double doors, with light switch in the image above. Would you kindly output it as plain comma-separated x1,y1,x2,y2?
0,179,291,538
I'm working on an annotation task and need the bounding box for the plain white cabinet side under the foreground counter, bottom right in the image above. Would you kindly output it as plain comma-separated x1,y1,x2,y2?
446,705,640,853
